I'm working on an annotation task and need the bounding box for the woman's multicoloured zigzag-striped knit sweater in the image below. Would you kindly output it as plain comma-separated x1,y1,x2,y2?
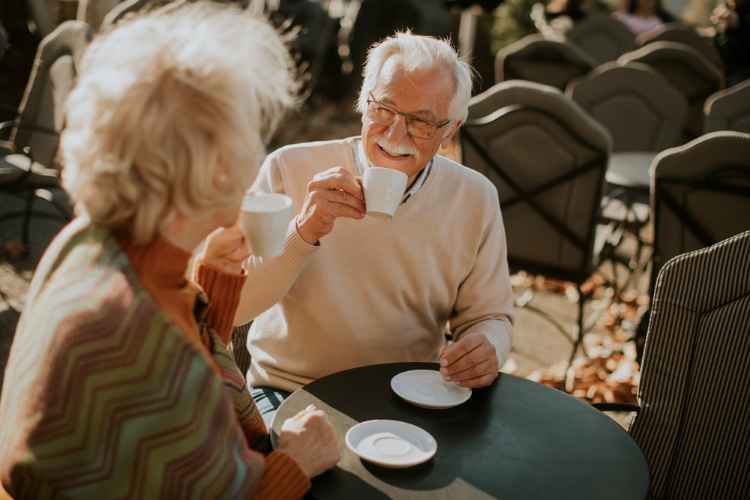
0,219,309,499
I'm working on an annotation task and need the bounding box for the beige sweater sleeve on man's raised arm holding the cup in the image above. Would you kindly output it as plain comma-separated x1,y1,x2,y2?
234,149,318,325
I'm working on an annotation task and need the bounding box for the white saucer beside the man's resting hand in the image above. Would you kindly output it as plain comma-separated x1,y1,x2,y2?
391,370,471,409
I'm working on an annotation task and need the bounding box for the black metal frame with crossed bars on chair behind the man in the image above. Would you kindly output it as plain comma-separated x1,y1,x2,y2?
461,105,607,367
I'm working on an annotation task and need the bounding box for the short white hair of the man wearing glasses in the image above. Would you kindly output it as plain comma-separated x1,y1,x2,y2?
357,31,472,122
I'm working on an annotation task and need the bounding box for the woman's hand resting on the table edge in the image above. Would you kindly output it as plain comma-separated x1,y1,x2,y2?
277,405,341,479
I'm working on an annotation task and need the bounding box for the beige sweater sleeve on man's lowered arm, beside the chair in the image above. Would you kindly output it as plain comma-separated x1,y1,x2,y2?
450,189,514,366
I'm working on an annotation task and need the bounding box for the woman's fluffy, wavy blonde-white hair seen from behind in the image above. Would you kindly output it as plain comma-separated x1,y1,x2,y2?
62,2,295,243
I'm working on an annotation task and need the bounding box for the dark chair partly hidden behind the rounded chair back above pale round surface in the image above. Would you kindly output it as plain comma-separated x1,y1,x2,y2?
619,42,724,140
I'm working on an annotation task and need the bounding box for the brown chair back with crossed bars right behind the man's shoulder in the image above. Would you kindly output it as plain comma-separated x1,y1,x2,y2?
461,80,611,284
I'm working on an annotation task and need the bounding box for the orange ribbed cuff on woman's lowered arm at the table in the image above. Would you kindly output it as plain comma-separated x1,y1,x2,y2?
253,451,310,500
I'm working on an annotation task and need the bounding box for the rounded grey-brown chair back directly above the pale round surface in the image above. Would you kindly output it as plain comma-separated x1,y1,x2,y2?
566,63,687,152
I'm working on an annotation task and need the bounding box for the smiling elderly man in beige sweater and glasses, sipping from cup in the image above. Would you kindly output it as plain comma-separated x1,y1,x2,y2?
235,33,513,415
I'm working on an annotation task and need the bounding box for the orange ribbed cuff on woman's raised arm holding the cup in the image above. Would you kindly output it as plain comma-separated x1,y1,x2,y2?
197,263,246,345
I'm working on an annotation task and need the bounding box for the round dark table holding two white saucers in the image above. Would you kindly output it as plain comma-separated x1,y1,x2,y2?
272,363,648,500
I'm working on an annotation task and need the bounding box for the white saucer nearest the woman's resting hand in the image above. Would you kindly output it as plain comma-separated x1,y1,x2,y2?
344,420,437,469
